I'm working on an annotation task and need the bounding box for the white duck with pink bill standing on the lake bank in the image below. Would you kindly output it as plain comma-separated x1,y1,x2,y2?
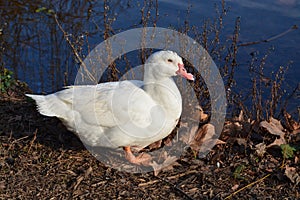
27,51,194,164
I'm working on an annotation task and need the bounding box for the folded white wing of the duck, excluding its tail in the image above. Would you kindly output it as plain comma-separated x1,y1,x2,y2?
66,81,155,128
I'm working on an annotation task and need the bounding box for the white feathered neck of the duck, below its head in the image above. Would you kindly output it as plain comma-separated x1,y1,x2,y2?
144,77,182,119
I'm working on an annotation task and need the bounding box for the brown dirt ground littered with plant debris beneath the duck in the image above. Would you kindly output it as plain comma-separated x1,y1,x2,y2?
0,82,300,199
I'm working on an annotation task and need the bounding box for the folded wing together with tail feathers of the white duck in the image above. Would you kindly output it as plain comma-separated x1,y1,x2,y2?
27,81,156,130
